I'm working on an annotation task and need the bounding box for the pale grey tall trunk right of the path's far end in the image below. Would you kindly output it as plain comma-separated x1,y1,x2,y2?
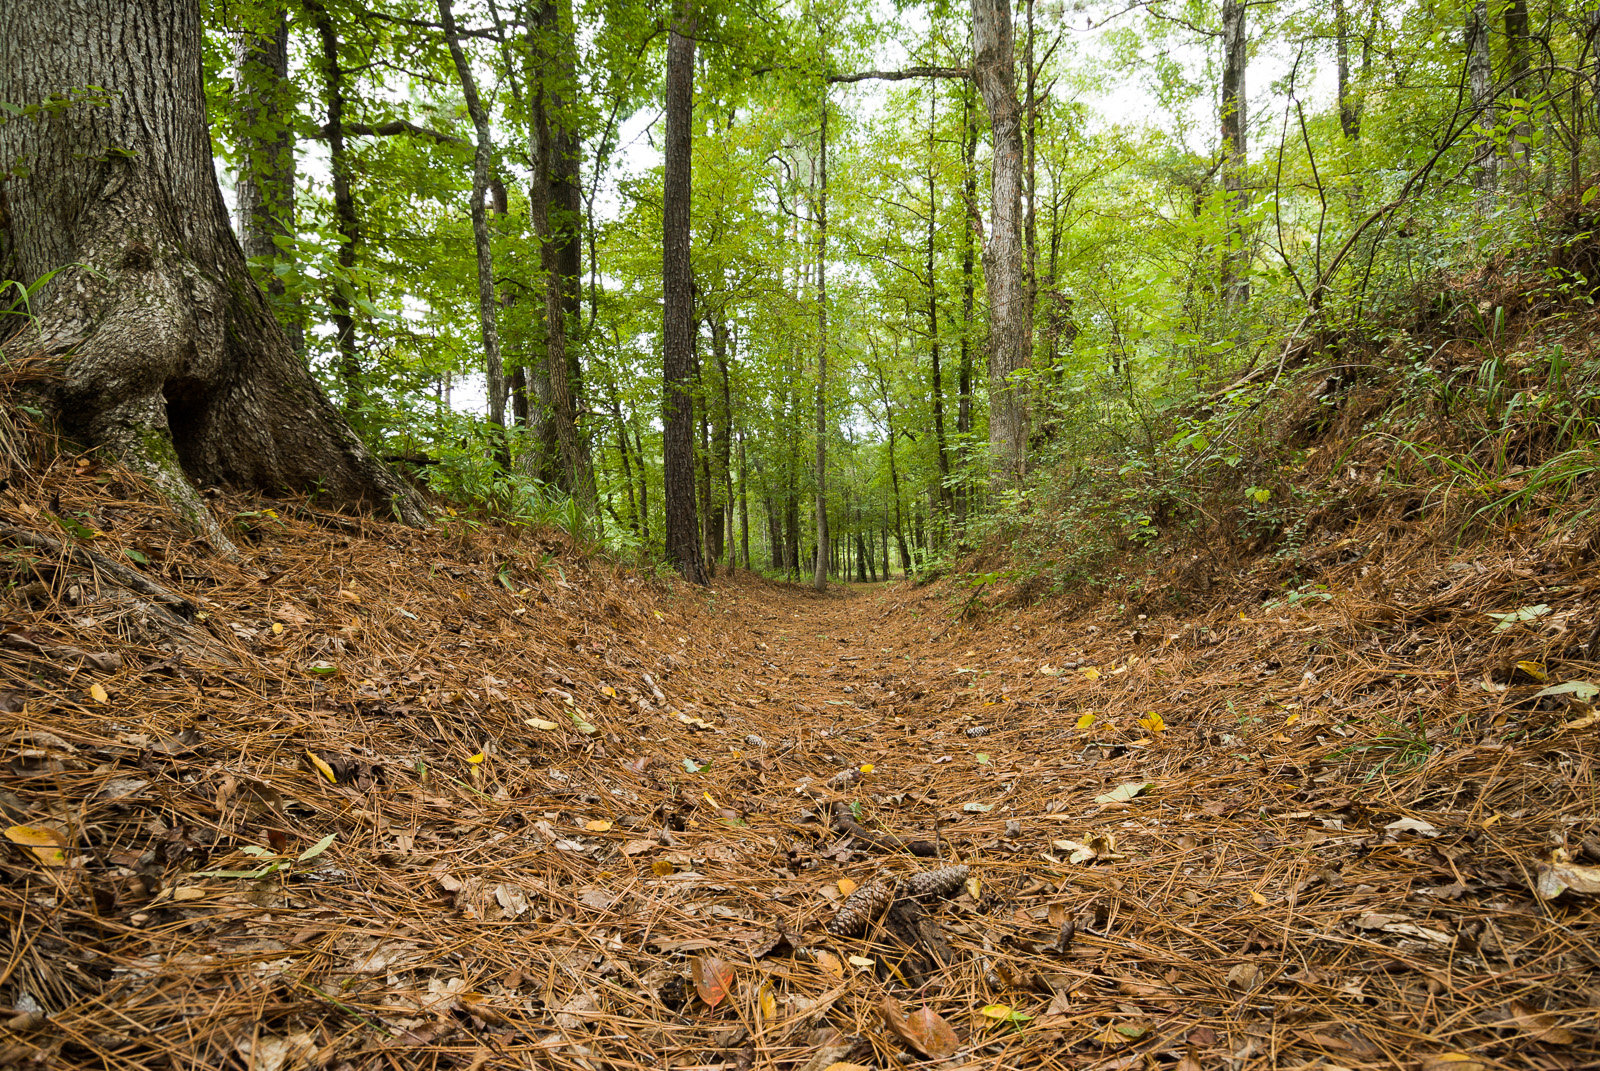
971,0,1030,488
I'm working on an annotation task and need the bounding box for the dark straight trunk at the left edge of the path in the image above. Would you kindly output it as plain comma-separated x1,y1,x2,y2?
661,4,706,584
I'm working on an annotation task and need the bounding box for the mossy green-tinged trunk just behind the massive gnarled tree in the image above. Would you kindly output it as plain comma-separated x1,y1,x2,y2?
234,6,306,354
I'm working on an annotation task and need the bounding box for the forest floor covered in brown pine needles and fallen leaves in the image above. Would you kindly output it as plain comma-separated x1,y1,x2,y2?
0,459,1600,1071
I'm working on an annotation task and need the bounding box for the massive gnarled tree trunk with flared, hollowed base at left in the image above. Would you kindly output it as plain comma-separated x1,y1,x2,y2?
0,0,424,549
